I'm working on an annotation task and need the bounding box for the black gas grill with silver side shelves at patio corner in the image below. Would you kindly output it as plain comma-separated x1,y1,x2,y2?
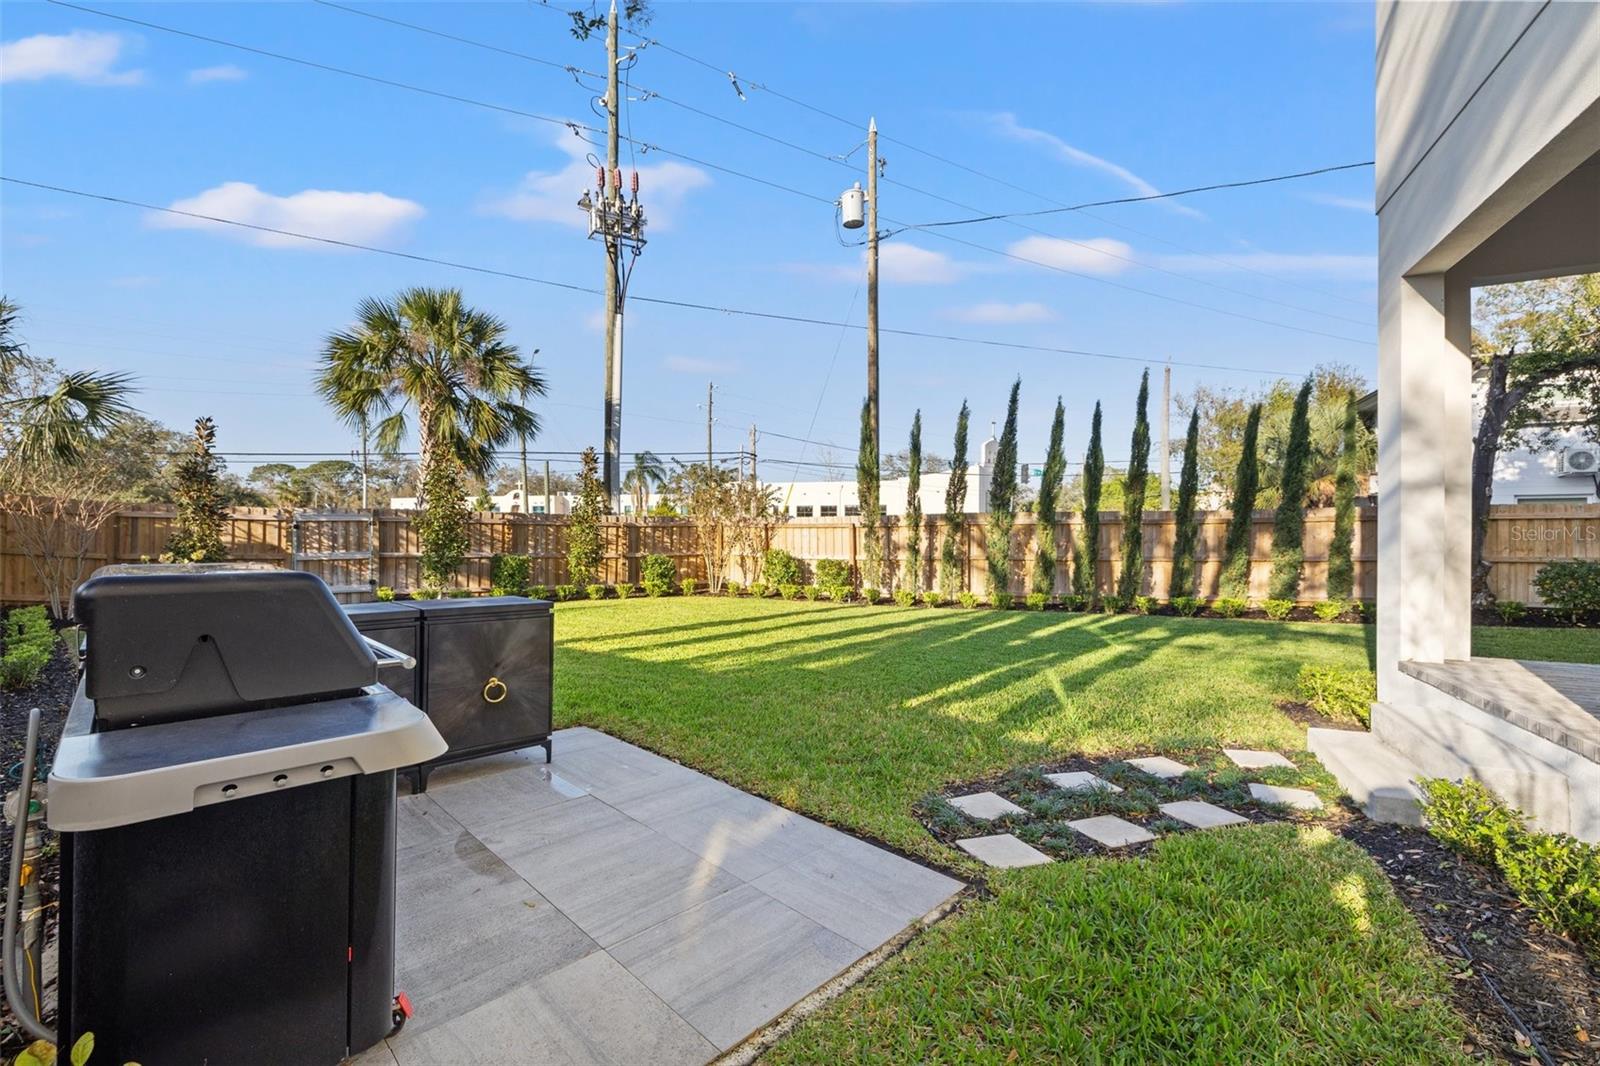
39,567,445,1066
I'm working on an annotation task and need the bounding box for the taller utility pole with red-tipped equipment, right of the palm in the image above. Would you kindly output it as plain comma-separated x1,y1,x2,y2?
578,0,645,507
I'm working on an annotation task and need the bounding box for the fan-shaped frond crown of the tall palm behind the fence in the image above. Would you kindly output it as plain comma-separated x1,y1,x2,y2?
317,288,546,482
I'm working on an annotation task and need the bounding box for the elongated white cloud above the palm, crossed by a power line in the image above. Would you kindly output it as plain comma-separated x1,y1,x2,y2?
147,181,424,248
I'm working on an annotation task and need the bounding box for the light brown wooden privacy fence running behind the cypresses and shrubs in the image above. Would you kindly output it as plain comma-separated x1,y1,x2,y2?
0,504,1600,605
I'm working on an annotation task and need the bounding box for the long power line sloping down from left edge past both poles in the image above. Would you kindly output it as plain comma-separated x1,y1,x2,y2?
0,174,1312,376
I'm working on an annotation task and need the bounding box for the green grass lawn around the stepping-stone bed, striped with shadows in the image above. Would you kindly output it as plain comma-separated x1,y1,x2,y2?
555,597,1536,1063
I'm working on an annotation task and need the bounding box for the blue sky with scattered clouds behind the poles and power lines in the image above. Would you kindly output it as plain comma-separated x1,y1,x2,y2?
0,0,1376,474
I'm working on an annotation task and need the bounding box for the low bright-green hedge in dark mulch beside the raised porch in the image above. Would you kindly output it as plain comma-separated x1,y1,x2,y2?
1421,778,1600,951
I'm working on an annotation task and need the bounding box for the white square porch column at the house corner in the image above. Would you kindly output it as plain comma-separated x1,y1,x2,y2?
1378,274,1472,701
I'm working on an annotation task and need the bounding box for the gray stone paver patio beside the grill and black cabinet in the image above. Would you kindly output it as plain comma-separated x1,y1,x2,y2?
377,728,960,1066
